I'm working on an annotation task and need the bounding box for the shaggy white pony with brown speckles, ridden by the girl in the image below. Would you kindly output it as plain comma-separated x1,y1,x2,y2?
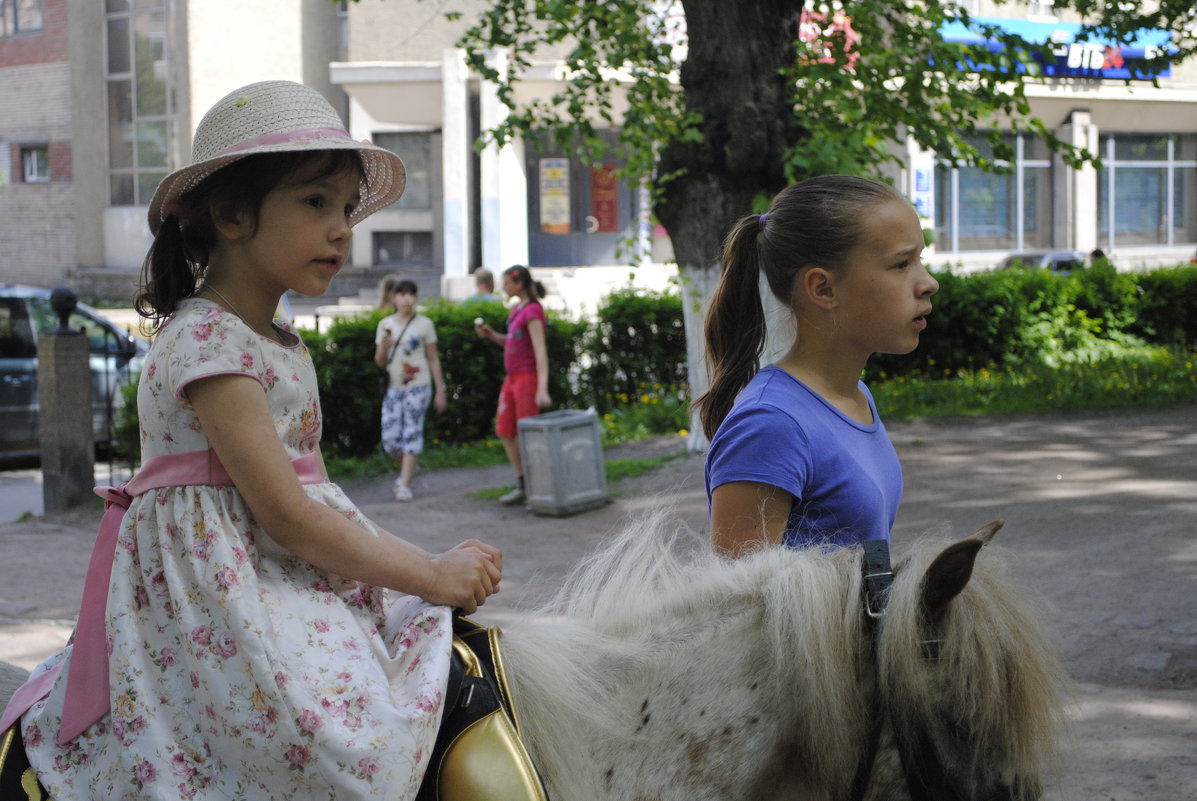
0,511,1065,801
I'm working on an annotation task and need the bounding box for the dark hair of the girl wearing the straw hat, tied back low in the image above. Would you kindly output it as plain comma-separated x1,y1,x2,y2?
133,150,365,326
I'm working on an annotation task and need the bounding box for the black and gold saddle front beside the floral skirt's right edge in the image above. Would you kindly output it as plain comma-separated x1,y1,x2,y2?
417,615,548,801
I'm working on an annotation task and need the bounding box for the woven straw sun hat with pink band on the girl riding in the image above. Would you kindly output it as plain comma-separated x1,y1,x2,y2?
143,80,407,236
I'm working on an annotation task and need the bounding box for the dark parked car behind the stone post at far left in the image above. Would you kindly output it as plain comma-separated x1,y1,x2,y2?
0,284,147,457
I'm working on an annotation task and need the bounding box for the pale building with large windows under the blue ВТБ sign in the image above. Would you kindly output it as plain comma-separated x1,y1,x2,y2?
903,0,1197,269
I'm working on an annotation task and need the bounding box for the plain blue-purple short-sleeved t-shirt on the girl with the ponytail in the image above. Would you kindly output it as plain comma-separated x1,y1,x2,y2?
706,365,903,547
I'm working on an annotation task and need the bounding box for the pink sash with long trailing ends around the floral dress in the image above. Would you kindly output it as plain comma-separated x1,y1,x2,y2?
0,450,328,745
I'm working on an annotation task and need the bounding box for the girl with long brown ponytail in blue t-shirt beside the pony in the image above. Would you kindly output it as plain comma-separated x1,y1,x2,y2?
697,175,938,557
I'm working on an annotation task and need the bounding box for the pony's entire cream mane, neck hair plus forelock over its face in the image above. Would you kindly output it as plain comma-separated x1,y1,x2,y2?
504,508,1063,797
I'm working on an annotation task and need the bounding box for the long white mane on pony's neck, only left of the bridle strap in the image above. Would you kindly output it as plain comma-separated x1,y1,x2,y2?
504,508,876,782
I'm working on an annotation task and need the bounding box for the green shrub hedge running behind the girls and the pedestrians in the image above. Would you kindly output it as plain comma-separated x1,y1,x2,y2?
114,265,1197,459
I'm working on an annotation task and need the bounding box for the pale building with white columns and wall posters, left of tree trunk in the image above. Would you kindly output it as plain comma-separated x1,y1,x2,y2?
330,0,675,311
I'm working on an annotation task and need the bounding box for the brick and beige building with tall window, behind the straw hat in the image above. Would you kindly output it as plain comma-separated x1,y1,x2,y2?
0,0,346,301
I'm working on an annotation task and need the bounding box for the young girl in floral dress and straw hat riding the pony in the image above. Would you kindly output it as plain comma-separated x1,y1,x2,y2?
0,81,502,801
